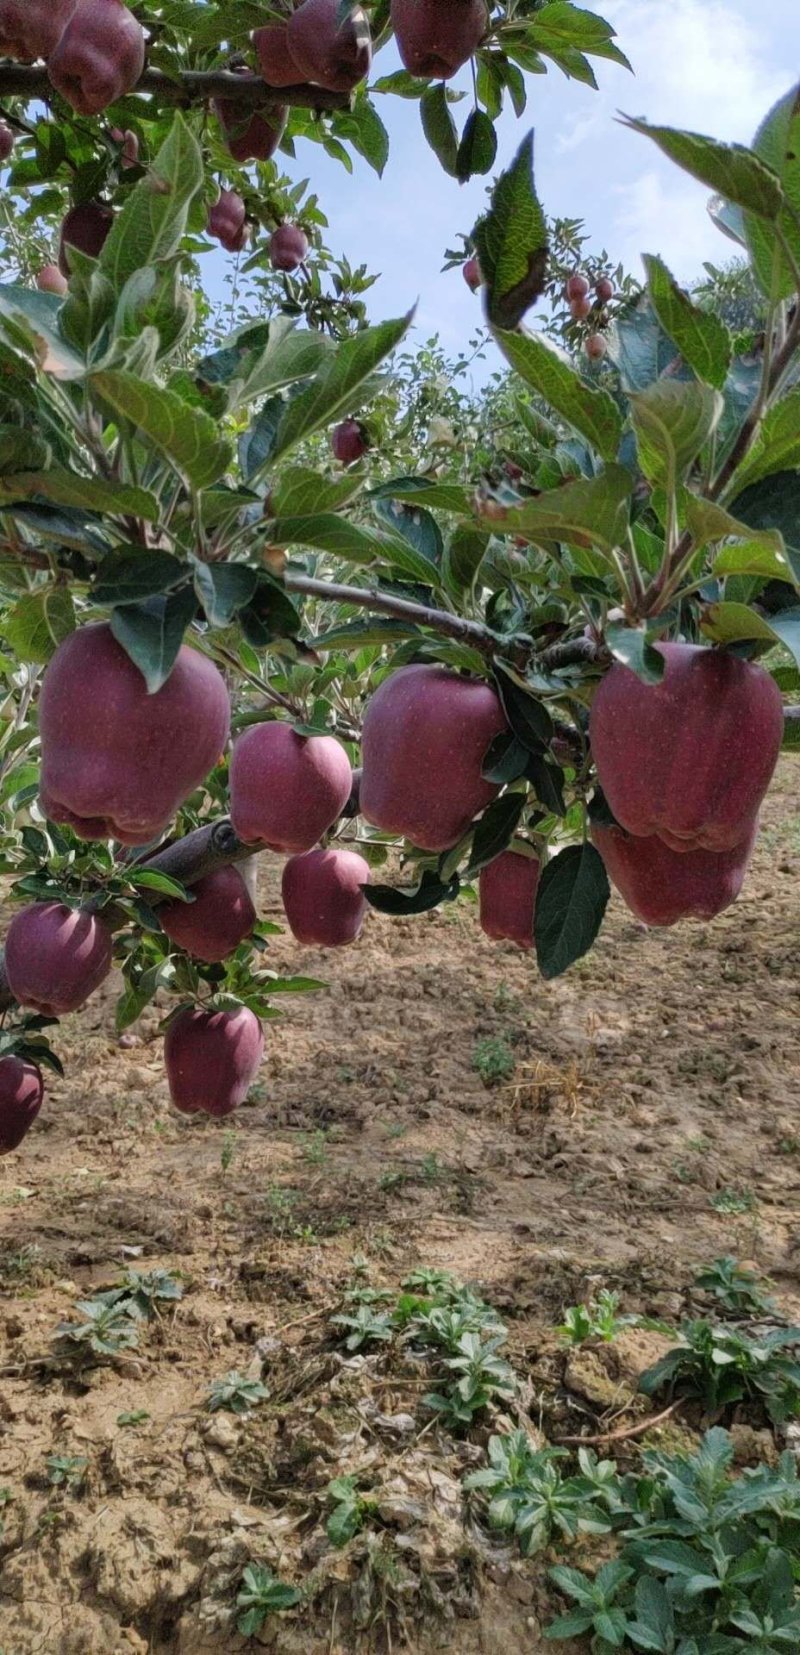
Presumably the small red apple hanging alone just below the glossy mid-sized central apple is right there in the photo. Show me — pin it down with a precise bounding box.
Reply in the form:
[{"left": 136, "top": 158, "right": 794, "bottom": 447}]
[{"left": 282, "top": 846, "right": 369, "bottom": 948}]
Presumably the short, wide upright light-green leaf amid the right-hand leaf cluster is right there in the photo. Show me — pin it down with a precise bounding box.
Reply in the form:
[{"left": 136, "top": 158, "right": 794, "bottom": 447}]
[{"left": 631, "top": 379, "right": 724, "bottom": 492}]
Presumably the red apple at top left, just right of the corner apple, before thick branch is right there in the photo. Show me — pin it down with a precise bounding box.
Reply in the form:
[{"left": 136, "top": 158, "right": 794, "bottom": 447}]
[{"left": 48, "top": 0, "right": 144, "bottom": 114}]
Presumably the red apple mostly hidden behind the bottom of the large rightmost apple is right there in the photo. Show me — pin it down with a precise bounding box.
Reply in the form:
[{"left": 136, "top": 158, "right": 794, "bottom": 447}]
[{"left": 591, "top": 821, "right": 759, "bottom": 925}]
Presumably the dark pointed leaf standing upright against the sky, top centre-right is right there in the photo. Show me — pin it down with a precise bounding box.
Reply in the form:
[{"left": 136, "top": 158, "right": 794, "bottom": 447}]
[{"left": 472, "top": 132, "right": 548, "bottom": 332}]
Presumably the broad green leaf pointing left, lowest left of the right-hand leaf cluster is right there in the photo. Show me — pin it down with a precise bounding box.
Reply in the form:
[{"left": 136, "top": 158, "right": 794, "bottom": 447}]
[{"left": 504, "top": 465, "right": 633, "bottom": 553}]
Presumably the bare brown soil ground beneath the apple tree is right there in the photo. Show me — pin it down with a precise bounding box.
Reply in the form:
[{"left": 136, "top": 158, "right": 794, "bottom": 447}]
[{"left": 0, "top": 761, "right": 800, "bottom": 1655}]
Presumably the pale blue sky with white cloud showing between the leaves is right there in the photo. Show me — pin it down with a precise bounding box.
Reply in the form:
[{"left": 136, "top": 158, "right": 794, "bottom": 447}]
[{"left": 250, "top": 0, "right": 800, "bottom": 366}]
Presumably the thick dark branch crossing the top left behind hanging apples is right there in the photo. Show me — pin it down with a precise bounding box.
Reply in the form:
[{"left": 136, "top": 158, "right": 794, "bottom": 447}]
[{"left": 0, "top": 63, "right": 351, "bottom": 109}]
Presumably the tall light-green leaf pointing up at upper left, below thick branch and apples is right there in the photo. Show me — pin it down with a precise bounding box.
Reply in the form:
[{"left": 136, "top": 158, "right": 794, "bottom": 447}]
[{"left": 99, "top": 113, "right": 205, "bottom": 293}]
